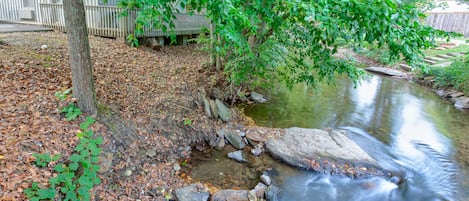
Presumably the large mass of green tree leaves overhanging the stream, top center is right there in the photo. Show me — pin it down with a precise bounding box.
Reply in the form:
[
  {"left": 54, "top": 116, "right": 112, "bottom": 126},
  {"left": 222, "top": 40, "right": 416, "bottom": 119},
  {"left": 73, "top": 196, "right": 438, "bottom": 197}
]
[{"left": 120, "top": 0, "right": 455, "bottom": 86}]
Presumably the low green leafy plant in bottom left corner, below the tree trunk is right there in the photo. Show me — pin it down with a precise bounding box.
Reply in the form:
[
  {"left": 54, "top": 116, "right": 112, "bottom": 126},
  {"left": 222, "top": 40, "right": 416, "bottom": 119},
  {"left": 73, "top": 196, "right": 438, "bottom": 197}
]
[{"left": 24, "top": 117, "right": 103, "bottom": 201}]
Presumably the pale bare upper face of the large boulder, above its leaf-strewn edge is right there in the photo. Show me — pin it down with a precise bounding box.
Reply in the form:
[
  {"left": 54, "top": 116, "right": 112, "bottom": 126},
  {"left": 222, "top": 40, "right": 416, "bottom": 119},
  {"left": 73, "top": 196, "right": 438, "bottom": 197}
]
[{"left": 266, "top": 128, "right": 377, "bottom": 171}]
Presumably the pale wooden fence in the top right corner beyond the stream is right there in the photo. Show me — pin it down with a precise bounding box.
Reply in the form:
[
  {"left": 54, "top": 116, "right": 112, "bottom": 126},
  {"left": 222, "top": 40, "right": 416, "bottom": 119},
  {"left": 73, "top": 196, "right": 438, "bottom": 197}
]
[{"left": 426, "top": 11, "right": 469, "bottom": 37}]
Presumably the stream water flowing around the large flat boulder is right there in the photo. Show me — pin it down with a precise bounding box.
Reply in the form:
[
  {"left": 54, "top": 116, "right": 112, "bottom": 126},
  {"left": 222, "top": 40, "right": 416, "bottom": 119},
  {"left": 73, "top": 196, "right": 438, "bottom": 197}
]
[{"left": 244, "top": 76, "right": 469, "bottom": 201}]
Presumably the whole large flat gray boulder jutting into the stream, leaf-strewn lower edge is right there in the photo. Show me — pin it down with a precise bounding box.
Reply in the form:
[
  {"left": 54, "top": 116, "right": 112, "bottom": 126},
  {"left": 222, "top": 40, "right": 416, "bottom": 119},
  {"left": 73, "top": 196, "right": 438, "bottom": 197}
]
[{"left": 266, "top": 128, "right": 384, "bottom": 177}]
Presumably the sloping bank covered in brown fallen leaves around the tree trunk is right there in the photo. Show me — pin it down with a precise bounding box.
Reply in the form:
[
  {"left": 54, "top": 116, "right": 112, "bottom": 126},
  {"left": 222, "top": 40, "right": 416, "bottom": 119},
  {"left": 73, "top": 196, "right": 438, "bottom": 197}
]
[{"left": 0, "top": 32, "right": 225, "bottom": 200}]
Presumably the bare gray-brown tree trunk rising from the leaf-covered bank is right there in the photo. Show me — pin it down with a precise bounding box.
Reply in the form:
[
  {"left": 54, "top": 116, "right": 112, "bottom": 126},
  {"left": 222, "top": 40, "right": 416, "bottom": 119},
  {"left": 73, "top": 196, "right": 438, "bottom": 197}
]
[{"left": 63, "top": 0, "right": 98, "bottom": 115}]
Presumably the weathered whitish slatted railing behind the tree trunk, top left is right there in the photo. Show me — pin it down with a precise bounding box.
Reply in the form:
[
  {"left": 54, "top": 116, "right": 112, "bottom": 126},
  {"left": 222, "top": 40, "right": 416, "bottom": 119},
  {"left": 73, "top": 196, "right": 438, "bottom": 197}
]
[{"left": 0, "top": 0, "right": 209, "bottom": 38}]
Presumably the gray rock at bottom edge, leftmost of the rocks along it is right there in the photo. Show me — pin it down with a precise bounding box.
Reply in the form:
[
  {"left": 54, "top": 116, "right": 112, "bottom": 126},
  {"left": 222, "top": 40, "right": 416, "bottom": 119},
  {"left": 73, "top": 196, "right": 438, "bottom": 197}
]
[{"left": 175, "top": 184, "right": 210, "bottom": 201}]
